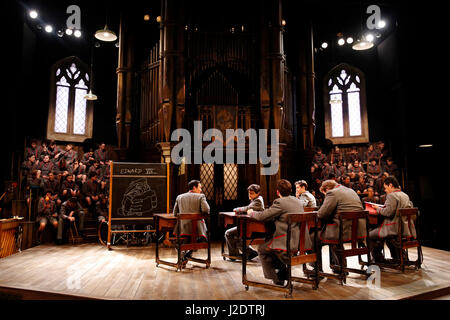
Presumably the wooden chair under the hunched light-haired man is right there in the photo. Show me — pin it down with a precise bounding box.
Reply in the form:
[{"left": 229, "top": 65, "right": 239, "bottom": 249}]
[{"left": 320, "top": 210, "right": 370, "bottom": 285}]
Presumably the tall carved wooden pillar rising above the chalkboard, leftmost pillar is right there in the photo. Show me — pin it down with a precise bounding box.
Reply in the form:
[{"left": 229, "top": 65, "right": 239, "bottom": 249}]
[{"left": 116, "top": 13, "right": 134, "bottom": 149}]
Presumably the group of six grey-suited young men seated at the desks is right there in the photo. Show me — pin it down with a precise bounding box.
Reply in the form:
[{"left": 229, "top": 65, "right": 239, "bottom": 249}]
[{"left": 173, "top": 177, "right": 416, "bottom": 285}]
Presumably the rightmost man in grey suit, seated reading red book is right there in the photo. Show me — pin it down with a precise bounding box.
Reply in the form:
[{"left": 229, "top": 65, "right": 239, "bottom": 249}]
[{"left": 369, "top": 176, "right": 417, "bottom": 262}]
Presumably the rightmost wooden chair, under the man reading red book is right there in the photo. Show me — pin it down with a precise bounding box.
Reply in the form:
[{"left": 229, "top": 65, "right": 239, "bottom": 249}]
[{"left": 374, "top": 208, "right": 423, "bottom": 272}]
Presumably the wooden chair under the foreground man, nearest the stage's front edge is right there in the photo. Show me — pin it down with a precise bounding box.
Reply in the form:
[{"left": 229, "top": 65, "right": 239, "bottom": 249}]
[{"left": 286, "top": 212, "right": 319, "bottom": 296}]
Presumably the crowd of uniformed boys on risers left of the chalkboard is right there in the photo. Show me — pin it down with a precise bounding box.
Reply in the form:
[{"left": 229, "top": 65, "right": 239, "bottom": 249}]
[{"left": 22, "top": 140, "right": 110, "bottom": 244}]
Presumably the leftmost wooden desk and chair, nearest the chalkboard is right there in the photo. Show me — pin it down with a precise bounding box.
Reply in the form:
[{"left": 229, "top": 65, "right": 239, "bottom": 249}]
[{"left": 155, "top": 213, "right": 211, "bottom": 271}]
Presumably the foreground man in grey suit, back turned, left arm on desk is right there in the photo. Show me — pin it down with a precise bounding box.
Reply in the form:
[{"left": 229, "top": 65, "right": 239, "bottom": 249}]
[{"left": 247, "top": 180, "right": 312, "bottom": 285}]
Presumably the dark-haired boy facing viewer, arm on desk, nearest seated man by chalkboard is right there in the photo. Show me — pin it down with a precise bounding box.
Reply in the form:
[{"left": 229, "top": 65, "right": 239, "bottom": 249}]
[{"left": 225, "top": 184, "right": 264, "bottom": 261}]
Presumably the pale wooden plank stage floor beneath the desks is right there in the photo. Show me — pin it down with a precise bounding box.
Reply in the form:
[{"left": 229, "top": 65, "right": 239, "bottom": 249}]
[{"left": 0, "top": 243, "right": 450, "bottom": 300}]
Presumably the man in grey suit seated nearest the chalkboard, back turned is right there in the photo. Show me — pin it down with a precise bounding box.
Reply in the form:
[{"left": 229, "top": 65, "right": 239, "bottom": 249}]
[{"left": 173, "top": 180, "right": 209, "bottom": 263}]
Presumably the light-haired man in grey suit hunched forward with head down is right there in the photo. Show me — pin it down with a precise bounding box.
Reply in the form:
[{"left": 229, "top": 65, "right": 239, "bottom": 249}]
[{"left": 317, "top": 180, "right": 366, "bottom": 272}]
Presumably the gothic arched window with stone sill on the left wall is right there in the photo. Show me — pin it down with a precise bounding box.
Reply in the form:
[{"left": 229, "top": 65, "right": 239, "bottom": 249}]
[{"left": 47, "top": 57, "right": 93, "bottom": 142}]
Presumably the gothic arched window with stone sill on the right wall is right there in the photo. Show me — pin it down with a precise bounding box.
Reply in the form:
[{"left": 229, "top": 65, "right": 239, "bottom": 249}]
[{"left": 324, "top": 64, "right": 369, "bottom": 144}]
